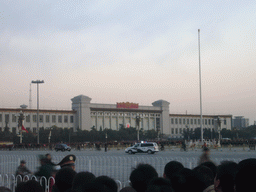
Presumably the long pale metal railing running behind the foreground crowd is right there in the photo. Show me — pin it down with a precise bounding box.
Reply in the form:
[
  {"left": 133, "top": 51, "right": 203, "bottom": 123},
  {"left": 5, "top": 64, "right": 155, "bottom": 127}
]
[{"left": 0, "top": 155, "right": 241, "bottom": 191}]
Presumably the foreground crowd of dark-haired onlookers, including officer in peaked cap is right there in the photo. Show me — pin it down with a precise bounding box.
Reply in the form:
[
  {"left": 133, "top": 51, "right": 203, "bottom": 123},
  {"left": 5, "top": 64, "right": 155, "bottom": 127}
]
[{"left": 0, "top": 147, "right": 256, "bottom": 192}]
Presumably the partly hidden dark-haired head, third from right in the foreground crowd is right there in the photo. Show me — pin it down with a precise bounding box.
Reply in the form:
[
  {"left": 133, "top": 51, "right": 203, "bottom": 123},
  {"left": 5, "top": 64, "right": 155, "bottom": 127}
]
[{"left": 193, "top": 165, "right": 214, "bottom": 188}]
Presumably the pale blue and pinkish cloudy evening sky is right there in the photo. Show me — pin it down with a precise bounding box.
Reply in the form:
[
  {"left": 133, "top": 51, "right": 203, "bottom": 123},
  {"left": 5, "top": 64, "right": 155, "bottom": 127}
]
[{"left": 0, "top": 0, "right": 256, "bottom": 124}]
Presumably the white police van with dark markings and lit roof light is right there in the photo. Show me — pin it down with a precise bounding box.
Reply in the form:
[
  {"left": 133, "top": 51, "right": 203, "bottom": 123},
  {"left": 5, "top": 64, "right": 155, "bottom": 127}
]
[{"left": 125, "top": 142, "right": 159, "bottom": 154}]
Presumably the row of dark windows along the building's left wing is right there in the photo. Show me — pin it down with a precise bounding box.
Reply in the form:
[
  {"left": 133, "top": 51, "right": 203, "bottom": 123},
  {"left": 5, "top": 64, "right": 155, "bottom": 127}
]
[{"left": 0, "top": 114, "right": 74, "bottom": 123}]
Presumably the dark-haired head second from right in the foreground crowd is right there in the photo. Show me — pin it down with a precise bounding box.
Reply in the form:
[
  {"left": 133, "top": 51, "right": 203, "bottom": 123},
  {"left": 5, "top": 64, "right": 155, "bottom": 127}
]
[{"left": 214, "top": 161, "right": 238, "bottom": 192}]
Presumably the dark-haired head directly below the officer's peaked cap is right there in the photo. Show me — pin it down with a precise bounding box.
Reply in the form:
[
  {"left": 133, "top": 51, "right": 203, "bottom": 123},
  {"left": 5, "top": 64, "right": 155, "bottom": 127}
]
[{"left": 55, "top": 167, "right": 76, "bottom": 192}]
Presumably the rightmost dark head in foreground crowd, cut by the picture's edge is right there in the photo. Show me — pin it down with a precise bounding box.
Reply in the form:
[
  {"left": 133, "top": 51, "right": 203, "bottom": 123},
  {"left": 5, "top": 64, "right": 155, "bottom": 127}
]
[{"left": 235, "top": 158, "right": 256, "bottom": 192}]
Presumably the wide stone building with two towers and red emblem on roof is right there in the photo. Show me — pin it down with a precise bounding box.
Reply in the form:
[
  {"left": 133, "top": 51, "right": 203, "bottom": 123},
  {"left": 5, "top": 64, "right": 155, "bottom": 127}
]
[{"left": 0, "top": 95, "right": 232, "bottom": 138}]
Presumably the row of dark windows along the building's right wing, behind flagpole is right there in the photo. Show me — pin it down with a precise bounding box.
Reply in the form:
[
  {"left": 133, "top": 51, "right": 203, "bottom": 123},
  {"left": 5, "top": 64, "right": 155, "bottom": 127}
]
[{"left": 171, "top": 118, "right": 227, "bottom": 125}]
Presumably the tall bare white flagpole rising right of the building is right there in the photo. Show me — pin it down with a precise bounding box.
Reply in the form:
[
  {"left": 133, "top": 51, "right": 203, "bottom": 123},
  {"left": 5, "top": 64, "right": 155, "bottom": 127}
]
[{"left": 198, "top": 29, "right": 204, "bottom": 143}]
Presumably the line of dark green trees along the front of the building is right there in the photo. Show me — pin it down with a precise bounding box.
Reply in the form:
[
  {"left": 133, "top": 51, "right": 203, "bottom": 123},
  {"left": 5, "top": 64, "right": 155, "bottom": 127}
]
[{"left": 0, "top": 125, "right": 256, "bottom": 144}]
